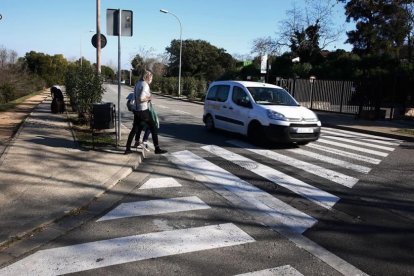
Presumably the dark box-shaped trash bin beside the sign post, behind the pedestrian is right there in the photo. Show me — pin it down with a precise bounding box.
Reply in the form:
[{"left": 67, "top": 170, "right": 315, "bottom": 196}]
[{"left": 91, "top": 103, "right": 115, "bottom": 129}]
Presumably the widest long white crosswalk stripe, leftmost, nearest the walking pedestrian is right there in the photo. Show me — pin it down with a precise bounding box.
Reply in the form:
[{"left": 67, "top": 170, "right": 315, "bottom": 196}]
[{"left": 166, "top": 150, "right": 317, "bottom": 233}]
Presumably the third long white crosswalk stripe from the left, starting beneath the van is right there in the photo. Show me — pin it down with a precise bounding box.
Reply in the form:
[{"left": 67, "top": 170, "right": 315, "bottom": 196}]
[{"left": 227, "top": 140, "right": 358, "bottom": 188}]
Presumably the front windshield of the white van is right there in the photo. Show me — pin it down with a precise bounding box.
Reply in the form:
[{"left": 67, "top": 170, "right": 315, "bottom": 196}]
[{"left": 247, "top": 87, "right": 299, "bottom": 106}]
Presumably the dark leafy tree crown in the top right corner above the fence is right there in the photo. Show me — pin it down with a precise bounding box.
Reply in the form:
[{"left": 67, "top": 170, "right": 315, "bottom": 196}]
[{"left": 340, "top": 0, "right": 414, "bottom": 58}]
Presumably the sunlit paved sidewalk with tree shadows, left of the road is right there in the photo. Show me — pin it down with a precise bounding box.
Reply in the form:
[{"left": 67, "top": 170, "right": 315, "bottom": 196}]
[{"left": 0, "top": 93, "right": 141, "bottom": 247}]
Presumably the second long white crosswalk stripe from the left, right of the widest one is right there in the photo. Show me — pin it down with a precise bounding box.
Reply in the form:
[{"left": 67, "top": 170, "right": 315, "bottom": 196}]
[{"left": 201, "top": 146, "right": 339, "bottom": 209}]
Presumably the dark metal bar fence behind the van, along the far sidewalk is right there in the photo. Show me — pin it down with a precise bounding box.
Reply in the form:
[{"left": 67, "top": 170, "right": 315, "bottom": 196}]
[{"left": 276, "top": 75, "right": 414, "bottom": 119}]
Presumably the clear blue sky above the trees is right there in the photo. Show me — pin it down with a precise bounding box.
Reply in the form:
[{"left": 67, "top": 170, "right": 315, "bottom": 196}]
[{"left": 0, "top": 0, "right": 351, "bottom": 69}]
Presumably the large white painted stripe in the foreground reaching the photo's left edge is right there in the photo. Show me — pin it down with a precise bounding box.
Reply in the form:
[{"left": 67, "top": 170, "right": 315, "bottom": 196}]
[{"left": 0, "top": 223, "right": 255, "bottom": 275}]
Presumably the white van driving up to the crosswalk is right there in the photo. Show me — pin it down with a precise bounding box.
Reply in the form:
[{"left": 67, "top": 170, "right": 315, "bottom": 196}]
[{"left": 203, "top": 81, "right": 321, "bottom": 144}]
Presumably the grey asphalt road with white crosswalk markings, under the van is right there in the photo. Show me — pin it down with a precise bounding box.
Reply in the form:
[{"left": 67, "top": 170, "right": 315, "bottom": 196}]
[{"left": 0, "top": 86, "right": 414, "bottom": 275}]
